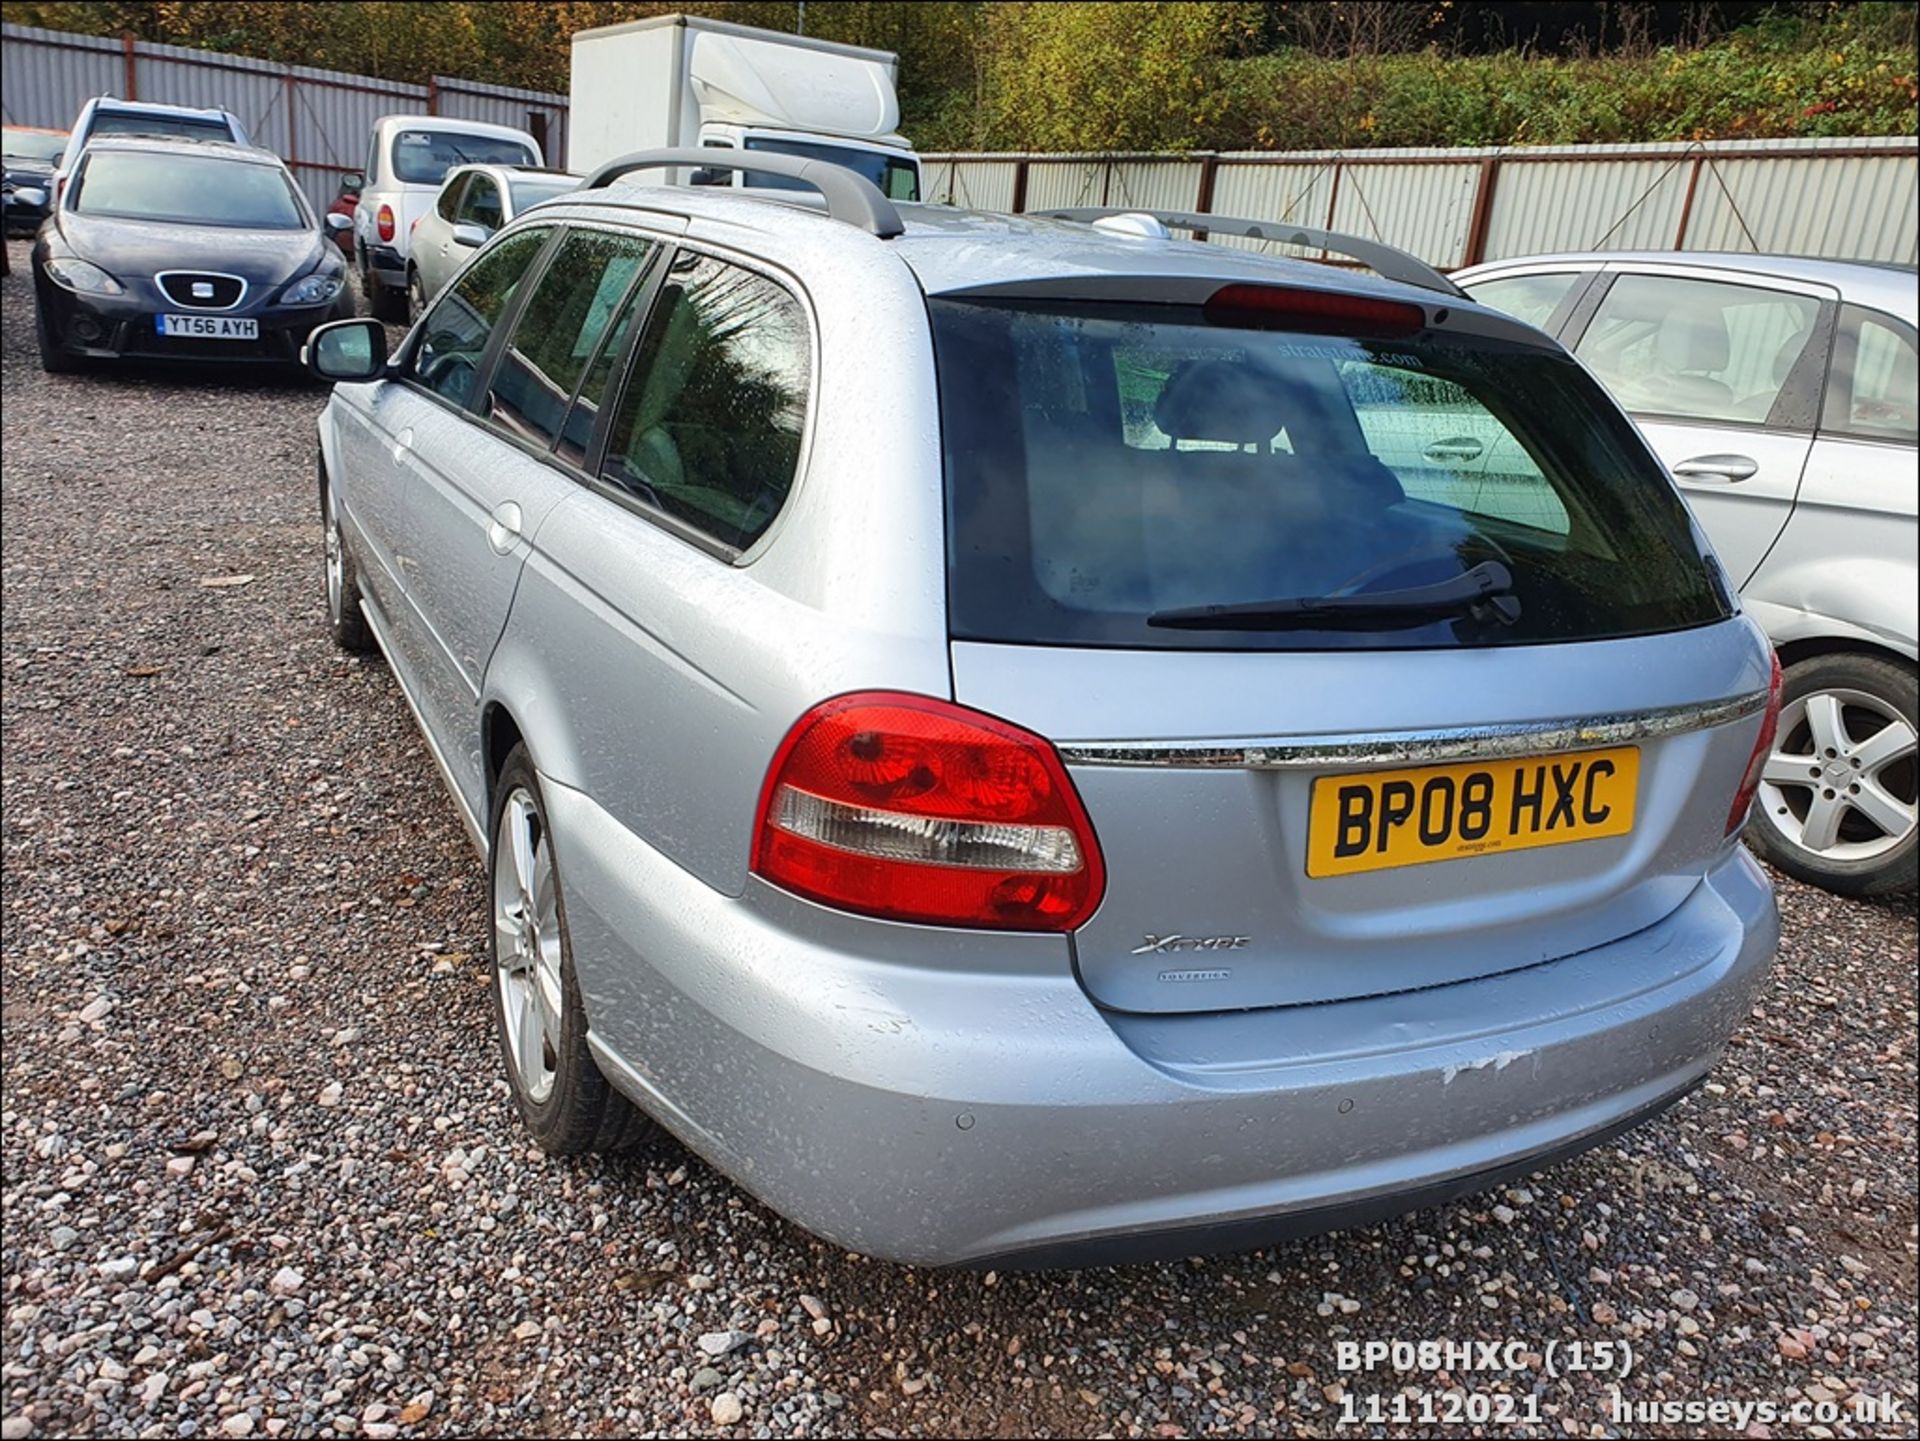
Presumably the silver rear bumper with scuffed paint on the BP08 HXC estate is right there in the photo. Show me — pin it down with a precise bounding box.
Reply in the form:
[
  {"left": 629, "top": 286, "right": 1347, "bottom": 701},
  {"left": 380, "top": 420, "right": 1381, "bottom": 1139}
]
[{"left": 547, "top": 781, "right": 1778, "bottom": 1264}]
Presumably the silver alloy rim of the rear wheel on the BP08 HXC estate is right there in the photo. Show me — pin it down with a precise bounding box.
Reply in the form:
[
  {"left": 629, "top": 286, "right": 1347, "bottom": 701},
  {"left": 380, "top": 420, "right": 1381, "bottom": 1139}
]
[{"left": 493, "top": 787, "right": 566, "bottom": 1105}]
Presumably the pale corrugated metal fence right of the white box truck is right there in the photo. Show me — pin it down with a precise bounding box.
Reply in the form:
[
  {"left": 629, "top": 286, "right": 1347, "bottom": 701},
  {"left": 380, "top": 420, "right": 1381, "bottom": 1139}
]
[{"left": 922, "top": 136, "right": 1920, "bottom": 269}]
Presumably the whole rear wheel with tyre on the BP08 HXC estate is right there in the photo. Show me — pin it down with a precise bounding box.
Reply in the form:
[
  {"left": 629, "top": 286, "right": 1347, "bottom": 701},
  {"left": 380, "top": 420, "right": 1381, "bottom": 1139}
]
[{"left": 488, "top": 746, "right": 655, "bottom": 1155}]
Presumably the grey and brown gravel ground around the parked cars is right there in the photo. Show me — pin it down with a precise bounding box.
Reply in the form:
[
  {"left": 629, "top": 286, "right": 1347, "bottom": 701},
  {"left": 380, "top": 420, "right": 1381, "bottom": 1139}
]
[{"left": 0, "top": 246, "right": 1916, "bottom": 1437}]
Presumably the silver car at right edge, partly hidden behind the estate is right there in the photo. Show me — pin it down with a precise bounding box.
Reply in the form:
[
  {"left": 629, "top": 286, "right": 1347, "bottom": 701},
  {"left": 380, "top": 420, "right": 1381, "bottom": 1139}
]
[{"left": 1453, "top": 251, "right": 1920, "bottom": 896}]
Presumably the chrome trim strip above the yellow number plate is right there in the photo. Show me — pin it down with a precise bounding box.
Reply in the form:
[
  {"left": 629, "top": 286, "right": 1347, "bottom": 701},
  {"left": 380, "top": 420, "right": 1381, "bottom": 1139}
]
[{"left": 1056, "top": 691, "right": 1766, "bottom": 771}]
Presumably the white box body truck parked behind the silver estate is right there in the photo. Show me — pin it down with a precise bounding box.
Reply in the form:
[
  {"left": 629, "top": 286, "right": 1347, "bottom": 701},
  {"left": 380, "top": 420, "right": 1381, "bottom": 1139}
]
[{"left": 566, "top": 15, "right": 920, "bottom": 200}]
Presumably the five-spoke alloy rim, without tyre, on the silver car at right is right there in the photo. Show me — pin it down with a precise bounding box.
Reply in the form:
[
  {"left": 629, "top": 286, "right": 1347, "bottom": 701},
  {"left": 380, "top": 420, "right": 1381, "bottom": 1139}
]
[{"left": 1759, "top": 689, "right": 1920, "bottom": 862}]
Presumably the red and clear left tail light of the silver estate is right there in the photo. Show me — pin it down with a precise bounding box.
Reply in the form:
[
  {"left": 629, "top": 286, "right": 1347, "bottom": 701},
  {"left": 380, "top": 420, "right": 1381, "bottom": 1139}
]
[{"left": 753, "top": 691, "right": 1106, "bottom": 931}]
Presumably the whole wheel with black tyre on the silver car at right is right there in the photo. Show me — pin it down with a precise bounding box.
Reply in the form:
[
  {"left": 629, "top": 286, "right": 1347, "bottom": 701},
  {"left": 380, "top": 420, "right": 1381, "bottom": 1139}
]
[{"left": 1747, "top": 652, "right": 1920, "bottom": 896}]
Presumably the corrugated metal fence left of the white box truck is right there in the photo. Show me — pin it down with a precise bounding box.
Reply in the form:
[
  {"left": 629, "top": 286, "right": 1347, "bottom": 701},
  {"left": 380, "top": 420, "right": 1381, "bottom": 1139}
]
[{"left": 0, "top": 25, "right": 566, "bottom": 209}]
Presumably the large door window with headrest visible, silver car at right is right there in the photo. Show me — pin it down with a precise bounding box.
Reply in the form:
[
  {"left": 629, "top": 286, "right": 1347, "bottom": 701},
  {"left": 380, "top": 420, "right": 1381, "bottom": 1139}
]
[{"left": 1574, "top": 274, "right": 1820, "bottom": 424}]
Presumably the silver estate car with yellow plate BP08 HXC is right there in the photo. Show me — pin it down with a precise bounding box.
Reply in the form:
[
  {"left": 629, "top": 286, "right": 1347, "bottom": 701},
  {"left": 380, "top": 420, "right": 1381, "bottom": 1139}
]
[{"left": 309, "top": 152, "right": 1778, "bottom": 1264}]
